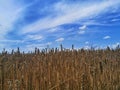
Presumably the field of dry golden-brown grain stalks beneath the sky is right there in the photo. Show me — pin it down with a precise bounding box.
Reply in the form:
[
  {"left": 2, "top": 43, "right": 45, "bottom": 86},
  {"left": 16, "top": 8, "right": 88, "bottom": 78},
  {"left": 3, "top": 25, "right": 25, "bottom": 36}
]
[{"left": 0, "top": 46, "right": 120, "bottom": 90}]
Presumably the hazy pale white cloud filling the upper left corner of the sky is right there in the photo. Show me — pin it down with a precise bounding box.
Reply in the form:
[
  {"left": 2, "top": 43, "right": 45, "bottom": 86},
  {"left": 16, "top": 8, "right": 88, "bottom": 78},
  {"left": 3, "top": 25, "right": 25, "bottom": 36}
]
[{"left": 0, "top": 0, "right": 31, "bottom": 39}]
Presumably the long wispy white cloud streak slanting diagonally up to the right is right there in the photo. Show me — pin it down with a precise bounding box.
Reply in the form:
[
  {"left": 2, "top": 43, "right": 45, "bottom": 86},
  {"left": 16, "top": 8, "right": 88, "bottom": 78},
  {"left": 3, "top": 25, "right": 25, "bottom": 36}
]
[{"left": 22, "top": 0, "right": 120, "bottom": 33}]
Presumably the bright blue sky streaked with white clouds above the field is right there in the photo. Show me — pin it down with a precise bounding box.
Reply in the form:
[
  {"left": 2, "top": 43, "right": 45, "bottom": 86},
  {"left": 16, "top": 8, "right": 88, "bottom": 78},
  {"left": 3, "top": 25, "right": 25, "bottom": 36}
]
[{"left": 0, "top": 0, "right": 120, "bottom": 51}]
